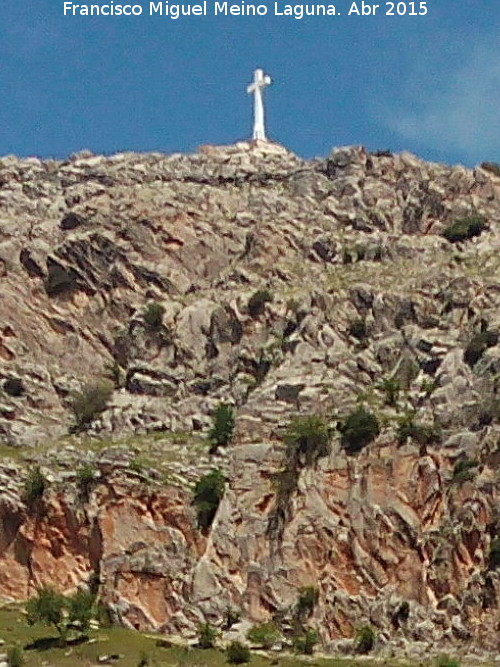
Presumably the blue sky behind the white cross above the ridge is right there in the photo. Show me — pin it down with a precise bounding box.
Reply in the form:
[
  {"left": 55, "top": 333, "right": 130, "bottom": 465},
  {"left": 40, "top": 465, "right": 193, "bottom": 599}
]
[{"left": 0, "top": 0, "right": 500, "bottom": 165}]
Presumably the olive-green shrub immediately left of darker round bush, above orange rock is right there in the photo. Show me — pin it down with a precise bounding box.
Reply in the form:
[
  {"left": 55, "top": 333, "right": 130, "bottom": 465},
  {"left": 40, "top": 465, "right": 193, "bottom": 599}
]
[{"left": 284, "top": 415, "right": 330, "bottom": 466}]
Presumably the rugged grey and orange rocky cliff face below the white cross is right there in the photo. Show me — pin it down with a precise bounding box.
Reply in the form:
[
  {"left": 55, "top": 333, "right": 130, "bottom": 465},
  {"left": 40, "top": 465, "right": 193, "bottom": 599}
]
[{"left": 0, "top": 144, "right": 500, "bottom": 649}]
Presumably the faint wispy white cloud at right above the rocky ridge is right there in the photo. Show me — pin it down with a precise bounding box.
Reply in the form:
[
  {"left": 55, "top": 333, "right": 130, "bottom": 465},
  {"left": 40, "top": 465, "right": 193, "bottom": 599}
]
[{"left": 385, "top": 42, "right": 500, "bottom": 162}]
